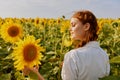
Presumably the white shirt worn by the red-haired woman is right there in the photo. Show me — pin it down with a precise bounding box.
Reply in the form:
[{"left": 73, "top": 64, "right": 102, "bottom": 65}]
[{"left": 61, "top": 41, "right": 110, "bottom": 80}]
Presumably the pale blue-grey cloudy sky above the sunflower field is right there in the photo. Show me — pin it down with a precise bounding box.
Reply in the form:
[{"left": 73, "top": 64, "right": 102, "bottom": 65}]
[{"left": 0, "top": 0, "right": 120, "bottom": 18}]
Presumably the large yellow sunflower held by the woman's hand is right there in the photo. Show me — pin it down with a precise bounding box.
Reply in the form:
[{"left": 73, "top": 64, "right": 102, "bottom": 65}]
[{"left": 12, "top": 36, "right": 44, "bottom": 70}]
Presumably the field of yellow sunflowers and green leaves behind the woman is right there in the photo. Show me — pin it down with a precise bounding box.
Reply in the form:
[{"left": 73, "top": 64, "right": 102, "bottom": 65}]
[{"left": 0, "top": 17, "right": 120, "bottom": 80}]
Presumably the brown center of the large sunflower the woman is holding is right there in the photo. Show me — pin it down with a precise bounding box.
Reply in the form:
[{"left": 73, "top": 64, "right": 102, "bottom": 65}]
[{"left": 23, "top": 44, "right": 37, "bottom": 62}]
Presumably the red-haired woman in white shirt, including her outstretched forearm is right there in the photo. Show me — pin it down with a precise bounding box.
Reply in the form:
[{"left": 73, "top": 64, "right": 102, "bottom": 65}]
[{"left": 23, "top": 10, "right": 110, "bottom": 80}]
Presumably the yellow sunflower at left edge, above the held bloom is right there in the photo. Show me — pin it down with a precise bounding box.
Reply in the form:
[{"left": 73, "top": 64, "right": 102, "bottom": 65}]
[{"left": 0, "top": 23, "right": 23, "bottom": 43}]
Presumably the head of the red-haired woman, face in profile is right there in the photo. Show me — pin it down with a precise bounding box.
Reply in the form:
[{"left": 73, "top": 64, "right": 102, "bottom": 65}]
[{"left": 70, "top": 10, "right": 98, "bottom": 46}]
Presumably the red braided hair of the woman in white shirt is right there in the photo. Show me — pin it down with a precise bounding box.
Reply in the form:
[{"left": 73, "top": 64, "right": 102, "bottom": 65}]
[{"left": 72, "top": 10, "right": 99, "bottom": 47}]
